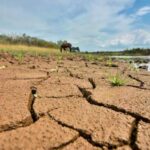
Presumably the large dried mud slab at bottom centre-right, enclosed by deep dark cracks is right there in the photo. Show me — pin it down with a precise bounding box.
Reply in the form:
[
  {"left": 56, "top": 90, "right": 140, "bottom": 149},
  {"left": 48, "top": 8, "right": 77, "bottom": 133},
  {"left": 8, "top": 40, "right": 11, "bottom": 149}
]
[{"left": 49, "top": 98, "right": 133, "bottom": 146}]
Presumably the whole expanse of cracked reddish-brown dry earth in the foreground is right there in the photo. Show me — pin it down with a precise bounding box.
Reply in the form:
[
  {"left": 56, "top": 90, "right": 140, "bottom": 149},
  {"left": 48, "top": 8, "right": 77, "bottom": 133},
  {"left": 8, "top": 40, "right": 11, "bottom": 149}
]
[{"left": 0, "top": 54, "right": 150, "bottom": 150}]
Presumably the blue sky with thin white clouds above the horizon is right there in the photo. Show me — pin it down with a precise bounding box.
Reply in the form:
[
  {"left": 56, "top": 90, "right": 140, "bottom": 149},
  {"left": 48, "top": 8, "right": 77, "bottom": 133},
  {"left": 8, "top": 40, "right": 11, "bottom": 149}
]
[{"left": 0, "top": 0, "right": 150, "bottom": 51}]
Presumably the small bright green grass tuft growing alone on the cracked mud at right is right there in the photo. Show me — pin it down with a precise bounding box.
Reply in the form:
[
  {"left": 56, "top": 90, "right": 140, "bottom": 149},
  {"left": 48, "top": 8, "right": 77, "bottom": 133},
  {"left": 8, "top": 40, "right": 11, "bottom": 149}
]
[{"left": 109, "top": 74, "right": 126, "bottom": 86}]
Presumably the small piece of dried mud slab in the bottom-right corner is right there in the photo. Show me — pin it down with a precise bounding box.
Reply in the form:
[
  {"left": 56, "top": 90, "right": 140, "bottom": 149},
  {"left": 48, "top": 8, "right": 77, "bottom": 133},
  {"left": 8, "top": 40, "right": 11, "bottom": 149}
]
[{"left": 136, "top": 121, "right": 150, "bottom": 150}]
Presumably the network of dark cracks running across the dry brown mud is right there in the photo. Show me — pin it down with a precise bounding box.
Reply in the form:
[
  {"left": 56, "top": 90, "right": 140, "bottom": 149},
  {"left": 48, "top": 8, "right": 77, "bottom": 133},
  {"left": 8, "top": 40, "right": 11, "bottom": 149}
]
[{"left": 0, "top": 55, "right": 150, "bottom": 150}]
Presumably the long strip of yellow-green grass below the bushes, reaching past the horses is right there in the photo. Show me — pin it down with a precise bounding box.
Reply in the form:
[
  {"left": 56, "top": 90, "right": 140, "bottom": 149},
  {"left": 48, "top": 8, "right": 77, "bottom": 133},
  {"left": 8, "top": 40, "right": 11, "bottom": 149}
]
[{"left": 0, "top": 44, "right": 105, "bottom": 62}]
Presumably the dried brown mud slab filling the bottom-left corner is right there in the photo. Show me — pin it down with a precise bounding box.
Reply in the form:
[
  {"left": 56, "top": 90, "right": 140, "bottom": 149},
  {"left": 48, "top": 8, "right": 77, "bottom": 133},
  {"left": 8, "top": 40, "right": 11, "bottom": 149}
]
[{"left": 0, "top": 117, "right": 78, "bottom": 150}]
